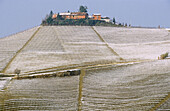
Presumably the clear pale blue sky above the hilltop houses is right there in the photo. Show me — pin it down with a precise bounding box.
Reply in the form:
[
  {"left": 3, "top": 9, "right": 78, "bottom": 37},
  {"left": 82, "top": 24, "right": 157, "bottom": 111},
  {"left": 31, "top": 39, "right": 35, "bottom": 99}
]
[{"left": 0, "top": 0, "right": 170, "bottom": 38}]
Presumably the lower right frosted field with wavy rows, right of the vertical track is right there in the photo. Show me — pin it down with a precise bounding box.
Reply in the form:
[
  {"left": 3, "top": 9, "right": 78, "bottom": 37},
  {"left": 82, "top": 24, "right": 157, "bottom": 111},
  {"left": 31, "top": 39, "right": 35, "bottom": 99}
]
[{"left": 82, "top": 60, "right": 170, "bottom": 111}]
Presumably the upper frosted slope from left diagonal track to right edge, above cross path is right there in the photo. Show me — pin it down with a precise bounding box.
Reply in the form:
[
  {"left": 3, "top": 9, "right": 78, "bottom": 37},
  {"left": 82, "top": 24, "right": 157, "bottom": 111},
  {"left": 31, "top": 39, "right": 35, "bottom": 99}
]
[{"left": 2, "top": 26, "right": 170, "bottom": 73}]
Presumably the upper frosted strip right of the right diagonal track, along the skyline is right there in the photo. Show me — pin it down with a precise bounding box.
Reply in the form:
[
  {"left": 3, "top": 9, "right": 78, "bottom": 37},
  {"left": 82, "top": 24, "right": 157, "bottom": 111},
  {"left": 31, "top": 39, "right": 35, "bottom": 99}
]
[{"left": 95, "top": 27, "right": 170, "bottom": 44}]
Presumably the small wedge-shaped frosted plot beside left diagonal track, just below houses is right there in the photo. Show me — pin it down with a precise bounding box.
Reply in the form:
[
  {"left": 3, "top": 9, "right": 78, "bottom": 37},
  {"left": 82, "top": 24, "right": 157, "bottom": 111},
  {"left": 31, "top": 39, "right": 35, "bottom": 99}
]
[{"left": 23, "top": 27, "right": 64, "bottom": 52}]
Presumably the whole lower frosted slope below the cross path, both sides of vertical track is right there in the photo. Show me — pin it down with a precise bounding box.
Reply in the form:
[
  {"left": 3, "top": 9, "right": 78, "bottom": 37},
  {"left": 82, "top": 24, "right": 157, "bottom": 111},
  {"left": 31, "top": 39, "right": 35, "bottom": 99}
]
[{"left": 0, "top": 59, "right": 170, "bottom": 111}]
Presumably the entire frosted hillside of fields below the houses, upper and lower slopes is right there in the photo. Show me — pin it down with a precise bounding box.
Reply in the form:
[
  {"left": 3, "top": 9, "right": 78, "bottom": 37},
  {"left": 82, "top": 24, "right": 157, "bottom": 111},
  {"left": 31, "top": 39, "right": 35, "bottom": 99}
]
[{"left": 0, "top": 26, "right": 170, "bottom": 111}]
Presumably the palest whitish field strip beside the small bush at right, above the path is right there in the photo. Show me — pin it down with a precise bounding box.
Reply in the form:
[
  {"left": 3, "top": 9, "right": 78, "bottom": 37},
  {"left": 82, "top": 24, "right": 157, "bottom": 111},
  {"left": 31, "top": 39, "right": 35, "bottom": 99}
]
[{"left": 110, "top": 42, "right": 170, "bottom": 60}]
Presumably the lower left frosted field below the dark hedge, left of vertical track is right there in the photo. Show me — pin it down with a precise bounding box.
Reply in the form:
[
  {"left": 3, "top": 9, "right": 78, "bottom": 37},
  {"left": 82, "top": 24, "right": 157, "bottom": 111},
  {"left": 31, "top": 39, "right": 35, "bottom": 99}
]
[{"left": 0, "top": 76, "right": 79, "bottom": 111}]
